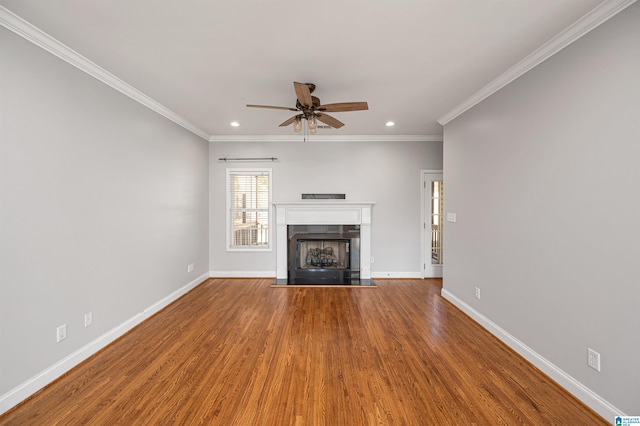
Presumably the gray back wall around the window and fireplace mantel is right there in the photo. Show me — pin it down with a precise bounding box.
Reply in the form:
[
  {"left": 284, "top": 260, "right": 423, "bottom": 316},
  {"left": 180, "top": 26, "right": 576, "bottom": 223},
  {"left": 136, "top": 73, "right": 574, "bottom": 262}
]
[{"left": 209, "top": 140, "right": 442, "bottom": 277}]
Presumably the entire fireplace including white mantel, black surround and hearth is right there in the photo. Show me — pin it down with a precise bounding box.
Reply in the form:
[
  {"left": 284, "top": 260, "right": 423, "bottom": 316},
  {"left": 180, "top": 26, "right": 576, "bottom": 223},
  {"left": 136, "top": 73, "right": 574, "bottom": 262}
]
[{"left": 274, "top": 200, "right": 375, "bottom": 286}]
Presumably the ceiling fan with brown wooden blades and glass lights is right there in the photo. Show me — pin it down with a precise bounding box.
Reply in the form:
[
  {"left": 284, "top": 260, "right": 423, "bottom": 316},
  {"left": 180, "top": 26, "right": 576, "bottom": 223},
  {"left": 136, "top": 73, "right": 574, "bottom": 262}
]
[{"left": 247, "top": 82, "right": 369, "bottom": 133}]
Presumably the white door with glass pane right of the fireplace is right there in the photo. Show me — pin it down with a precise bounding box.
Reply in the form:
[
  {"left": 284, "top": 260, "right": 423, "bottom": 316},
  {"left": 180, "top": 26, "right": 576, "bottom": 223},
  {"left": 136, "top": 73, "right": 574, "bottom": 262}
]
[{"left": 422, "top": 172, "right": 444, "bottom": 278}]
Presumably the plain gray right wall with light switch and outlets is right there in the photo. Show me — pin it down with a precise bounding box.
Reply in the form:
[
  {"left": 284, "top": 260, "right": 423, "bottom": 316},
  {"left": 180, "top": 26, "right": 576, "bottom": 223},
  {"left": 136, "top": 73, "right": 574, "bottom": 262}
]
[{"left": 444, "top": 3, "right": 640, "bottom": 415}]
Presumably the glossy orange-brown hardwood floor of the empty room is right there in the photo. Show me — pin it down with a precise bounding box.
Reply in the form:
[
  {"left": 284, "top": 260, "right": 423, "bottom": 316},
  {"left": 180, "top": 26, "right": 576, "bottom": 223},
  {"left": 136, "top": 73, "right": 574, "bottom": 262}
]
[{"left": 0, "top": 279, "right": 609, "bottom": 426}]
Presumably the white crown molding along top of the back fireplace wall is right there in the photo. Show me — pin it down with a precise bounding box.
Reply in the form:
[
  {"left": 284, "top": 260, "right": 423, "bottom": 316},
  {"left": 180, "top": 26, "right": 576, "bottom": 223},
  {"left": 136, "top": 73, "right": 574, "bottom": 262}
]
[{"left": 209, "top": 134, "right": 443, "bottom": 142}]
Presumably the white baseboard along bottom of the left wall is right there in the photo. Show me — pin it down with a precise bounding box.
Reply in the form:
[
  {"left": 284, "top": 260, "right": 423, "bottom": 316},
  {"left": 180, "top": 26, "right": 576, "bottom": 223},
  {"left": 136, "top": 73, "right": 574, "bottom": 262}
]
[{"left": 0, "top": 273, "right": 209, "bottom": 414}]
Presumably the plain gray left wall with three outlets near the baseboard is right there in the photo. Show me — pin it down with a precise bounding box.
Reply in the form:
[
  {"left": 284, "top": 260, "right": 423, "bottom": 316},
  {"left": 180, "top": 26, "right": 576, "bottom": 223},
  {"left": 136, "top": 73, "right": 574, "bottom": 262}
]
[{"left": 0, "top": 28, "right": 209, "bottom": 395}]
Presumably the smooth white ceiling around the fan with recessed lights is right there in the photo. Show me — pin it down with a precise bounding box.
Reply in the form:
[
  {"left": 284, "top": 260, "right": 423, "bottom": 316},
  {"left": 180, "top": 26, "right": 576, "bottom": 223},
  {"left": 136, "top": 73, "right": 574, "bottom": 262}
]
[{"left": 0, "top": 0, "right": 603, "bottom": 139}]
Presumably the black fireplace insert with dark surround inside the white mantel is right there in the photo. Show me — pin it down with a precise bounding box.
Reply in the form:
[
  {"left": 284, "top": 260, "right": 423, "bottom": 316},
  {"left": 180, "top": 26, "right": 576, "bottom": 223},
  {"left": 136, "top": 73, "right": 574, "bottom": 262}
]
[{"left": 287, "top": 225, "right": 360, "bottom": 284}]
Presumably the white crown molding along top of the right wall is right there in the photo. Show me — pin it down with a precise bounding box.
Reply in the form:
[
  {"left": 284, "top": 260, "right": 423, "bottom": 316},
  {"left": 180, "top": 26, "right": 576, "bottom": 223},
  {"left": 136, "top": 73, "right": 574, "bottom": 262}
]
[{"left": 438, "top": 0, "right": 636, "bottom": 126}]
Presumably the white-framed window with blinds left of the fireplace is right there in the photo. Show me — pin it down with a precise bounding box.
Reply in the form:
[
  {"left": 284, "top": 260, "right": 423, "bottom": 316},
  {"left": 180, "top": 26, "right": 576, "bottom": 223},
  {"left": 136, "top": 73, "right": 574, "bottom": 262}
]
[{"left": 227, "top": 169, "right": 271, "bottom": 250}]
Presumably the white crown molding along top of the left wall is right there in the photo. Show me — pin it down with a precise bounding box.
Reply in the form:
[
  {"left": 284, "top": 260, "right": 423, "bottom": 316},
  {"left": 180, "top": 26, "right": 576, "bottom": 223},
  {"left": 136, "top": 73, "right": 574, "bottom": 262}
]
[{"left": 0, "top": 6, "right": 209, "bottom": 140}]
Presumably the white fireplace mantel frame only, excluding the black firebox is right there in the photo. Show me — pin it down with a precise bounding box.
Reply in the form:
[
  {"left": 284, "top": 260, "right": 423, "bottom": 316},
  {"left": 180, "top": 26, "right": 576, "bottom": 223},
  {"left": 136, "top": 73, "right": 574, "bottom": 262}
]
[{"left": 273, "top": 200, "right": 374, "bottom": 279}]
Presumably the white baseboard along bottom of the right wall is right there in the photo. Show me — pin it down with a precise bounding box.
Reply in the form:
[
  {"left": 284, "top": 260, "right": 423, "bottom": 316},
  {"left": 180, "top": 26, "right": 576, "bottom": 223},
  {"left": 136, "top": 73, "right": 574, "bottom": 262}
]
[{"left": 442, "top": 289, "right": 625, "bottom": 420}]
